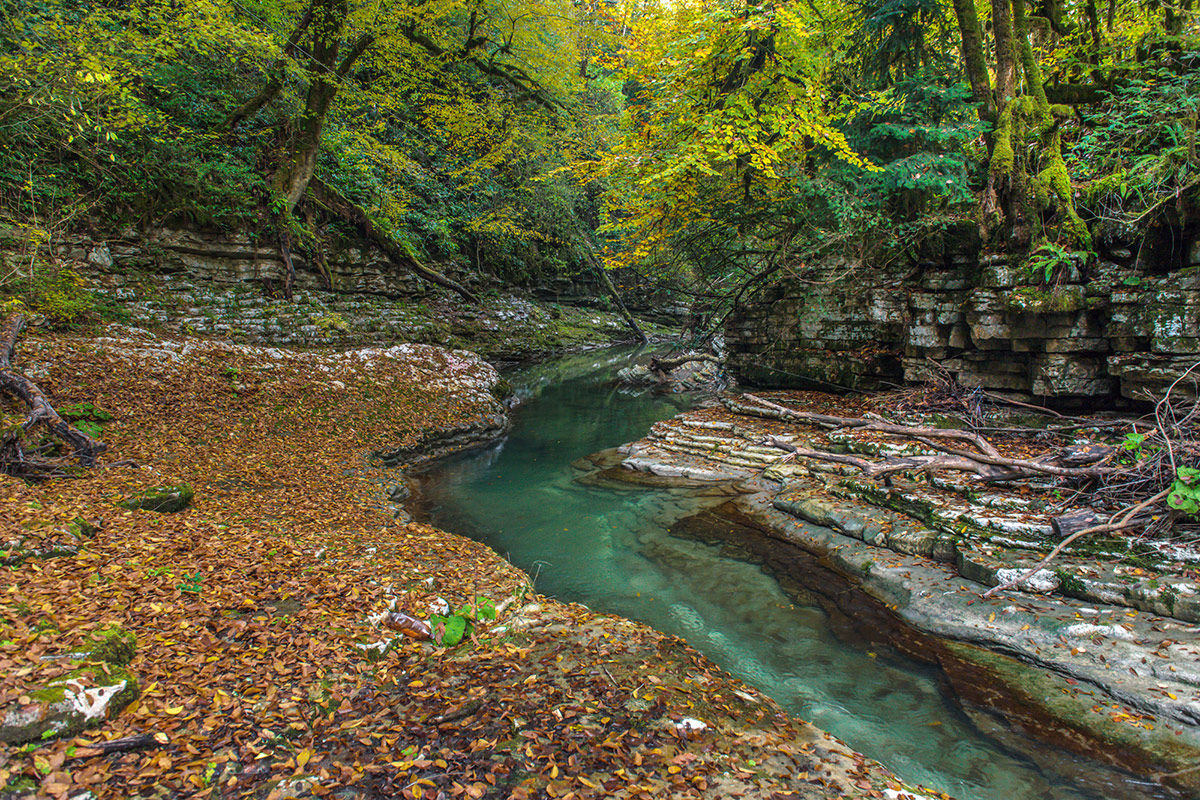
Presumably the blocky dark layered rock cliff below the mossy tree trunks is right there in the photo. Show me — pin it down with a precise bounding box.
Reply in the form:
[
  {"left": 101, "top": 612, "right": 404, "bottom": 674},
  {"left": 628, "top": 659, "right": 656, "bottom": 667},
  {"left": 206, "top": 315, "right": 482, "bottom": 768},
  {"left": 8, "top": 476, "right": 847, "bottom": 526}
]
[{"left": 726, "top": 226, "right": 1200, "bottom": 404}]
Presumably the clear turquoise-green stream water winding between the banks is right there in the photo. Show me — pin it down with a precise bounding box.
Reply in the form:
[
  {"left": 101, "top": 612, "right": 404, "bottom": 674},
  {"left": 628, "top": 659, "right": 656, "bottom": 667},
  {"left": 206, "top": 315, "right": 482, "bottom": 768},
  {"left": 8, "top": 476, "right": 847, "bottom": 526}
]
[{"left": 425, "top": 351, "right": 1148, "bottom": 800}]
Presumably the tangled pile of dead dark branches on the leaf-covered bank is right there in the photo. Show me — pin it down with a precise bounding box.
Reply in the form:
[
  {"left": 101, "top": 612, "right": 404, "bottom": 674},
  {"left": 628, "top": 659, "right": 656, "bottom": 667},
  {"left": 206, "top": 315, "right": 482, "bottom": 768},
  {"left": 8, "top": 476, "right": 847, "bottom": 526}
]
[{"left": 0, "top": 313, "right": 107, "bottom": 480}]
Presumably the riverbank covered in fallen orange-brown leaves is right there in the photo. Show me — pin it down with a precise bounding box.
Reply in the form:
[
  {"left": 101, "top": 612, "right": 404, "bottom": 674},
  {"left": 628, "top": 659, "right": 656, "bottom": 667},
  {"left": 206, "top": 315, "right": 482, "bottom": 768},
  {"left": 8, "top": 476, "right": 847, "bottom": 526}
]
[{"left": 0, "top": 329, "right": 926, "bottom": 799}]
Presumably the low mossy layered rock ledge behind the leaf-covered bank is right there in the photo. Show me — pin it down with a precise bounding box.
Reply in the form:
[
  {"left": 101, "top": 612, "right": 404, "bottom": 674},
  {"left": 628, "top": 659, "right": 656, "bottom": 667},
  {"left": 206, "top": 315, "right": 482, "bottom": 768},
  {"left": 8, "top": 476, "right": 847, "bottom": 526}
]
[{"left": 23, "top": 229, "right": 672, "bottom": 360}]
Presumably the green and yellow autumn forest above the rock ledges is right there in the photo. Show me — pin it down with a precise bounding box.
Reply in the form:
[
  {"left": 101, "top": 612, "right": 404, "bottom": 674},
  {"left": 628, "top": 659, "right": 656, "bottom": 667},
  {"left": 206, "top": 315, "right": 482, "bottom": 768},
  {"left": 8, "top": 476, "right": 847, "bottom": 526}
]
[{"left": 0, "top": 0, "right": 1200, "bottom": 307}]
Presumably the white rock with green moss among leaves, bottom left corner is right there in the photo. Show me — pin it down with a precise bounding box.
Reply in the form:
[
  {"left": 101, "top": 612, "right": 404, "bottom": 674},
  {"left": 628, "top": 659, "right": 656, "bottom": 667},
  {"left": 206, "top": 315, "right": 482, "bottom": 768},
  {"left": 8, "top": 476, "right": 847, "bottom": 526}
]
[{"left": 0, "top": 663, "right": 139, "bottom": 745}]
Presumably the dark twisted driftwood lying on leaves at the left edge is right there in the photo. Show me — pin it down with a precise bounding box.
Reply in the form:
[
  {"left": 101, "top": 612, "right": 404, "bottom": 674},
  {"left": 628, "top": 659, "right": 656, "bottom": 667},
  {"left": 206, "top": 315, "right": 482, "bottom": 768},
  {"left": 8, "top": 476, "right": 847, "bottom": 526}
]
[{"left": 0, "top": 313, "right": 108, "bottom": 476}]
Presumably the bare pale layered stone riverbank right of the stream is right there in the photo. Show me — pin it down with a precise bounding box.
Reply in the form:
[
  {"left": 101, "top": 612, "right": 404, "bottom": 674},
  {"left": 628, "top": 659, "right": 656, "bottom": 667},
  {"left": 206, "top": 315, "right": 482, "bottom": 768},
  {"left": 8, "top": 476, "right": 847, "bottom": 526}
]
[{"left": 595, "top": 392, "right": 1200, "bottom": 796}]
